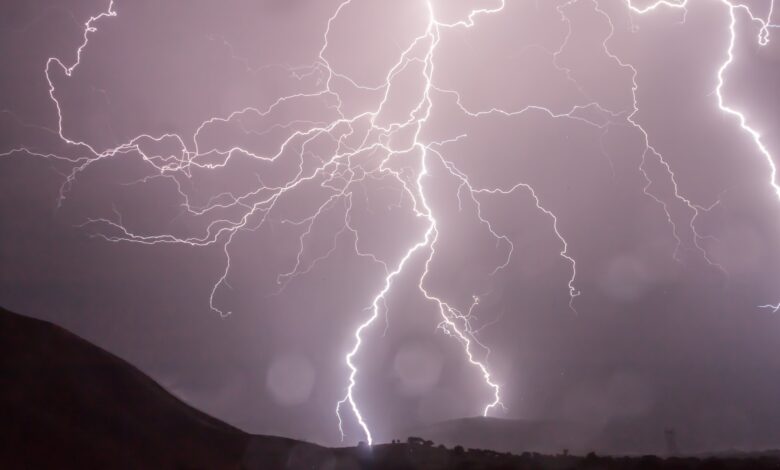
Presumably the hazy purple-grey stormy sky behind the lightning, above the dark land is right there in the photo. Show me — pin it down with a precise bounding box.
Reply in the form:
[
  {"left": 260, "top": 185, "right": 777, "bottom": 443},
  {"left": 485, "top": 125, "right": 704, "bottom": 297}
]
[{"left": 0, "top": 0, "right": 780, "bottom": 451}]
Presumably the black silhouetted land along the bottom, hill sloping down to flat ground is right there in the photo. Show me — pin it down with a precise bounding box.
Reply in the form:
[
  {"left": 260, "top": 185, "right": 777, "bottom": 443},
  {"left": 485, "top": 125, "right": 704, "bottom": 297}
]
[{"left": 0, "top": 309, "right": 780, "bottom": 470}]
